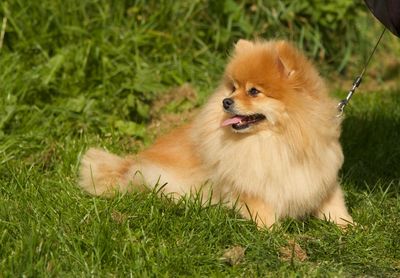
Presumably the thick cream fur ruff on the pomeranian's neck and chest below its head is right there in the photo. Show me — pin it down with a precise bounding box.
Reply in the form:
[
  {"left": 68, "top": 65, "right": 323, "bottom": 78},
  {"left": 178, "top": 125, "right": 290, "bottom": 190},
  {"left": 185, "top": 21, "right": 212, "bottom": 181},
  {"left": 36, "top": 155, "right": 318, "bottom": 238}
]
[{"left": 195, "top": 109, "right": 343, "bottom": 217}]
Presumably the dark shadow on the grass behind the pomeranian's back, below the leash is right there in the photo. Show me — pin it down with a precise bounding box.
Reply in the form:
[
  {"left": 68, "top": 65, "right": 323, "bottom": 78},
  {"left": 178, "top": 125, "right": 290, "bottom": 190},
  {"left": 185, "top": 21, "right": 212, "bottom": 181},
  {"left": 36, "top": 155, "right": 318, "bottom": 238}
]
[{"left": 341, "top": 92, "right": 400, "bottom": 193}]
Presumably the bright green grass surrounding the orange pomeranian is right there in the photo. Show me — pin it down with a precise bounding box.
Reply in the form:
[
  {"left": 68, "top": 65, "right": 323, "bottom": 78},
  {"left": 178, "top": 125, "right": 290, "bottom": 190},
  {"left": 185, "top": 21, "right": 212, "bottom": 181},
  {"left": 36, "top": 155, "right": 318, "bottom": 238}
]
[{"left": 0, "top": 0, "right": 400, "bottom": 277}]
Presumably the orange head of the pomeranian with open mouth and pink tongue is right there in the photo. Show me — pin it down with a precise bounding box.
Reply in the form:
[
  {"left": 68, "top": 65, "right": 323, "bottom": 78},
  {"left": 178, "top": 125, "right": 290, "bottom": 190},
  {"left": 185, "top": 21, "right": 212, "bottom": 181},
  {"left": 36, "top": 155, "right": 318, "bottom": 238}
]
[{"left": 221, "top": 40, "right": 319, "bottom": 133}]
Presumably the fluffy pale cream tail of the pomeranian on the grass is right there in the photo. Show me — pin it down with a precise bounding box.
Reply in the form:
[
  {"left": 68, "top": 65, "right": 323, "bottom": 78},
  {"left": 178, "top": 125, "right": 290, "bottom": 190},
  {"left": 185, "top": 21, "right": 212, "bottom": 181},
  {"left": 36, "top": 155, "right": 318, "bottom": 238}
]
[{"left": 79, "top": 148, "right": 133, "bottom": 197}]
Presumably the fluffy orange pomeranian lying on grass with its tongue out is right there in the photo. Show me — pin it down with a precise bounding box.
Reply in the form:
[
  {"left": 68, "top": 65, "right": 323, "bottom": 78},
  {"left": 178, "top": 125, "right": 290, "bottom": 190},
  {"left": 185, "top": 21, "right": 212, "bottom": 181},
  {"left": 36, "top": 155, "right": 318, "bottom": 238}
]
[{"left": 80, "top": 40, "right": 352, "bottom": 227}]
